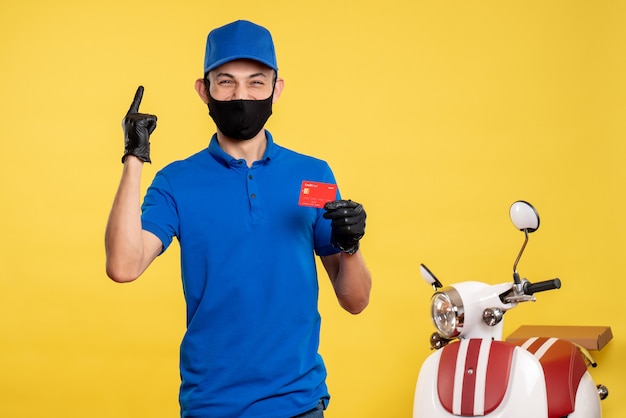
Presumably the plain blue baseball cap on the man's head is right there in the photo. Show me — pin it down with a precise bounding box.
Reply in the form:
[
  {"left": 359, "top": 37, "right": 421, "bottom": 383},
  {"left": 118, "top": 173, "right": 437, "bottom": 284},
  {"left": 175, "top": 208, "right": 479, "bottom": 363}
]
[{"left": 204, "top": 20, "right": 278, "bottom": 75}]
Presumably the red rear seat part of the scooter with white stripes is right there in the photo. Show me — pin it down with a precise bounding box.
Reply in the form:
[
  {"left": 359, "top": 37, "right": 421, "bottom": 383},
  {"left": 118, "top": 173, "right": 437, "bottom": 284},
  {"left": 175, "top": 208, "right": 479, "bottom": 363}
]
[{"left": 517, "top": 337, "right": 587, "bottom": 418}]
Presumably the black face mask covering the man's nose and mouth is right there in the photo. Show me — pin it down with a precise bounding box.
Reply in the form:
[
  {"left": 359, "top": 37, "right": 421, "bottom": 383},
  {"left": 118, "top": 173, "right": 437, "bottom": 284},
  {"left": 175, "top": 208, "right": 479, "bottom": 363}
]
[{"left": 207, "top": 89, "right": 274, "bottom": 139}]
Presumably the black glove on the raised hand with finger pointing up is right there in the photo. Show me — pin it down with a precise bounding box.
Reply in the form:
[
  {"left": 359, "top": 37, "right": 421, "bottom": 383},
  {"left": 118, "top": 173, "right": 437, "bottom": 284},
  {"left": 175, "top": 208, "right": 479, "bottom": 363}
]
[{"left": 122, "top": 86, "right": 157, "bottom": 163}]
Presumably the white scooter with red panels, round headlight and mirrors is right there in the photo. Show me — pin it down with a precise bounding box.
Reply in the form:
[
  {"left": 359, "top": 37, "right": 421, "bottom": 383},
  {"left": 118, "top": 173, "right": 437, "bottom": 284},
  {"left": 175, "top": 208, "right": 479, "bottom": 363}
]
[{"left": 413, "top": 201, "right": 608, "bottom": 418}]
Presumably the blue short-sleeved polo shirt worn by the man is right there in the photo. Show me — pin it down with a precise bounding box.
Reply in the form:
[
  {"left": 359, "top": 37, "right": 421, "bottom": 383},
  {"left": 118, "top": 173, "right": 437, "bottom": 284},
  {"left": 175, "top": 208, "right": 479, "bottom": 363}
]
[{"left": 142, "top": 131, "right": 339, "bottom": 418}]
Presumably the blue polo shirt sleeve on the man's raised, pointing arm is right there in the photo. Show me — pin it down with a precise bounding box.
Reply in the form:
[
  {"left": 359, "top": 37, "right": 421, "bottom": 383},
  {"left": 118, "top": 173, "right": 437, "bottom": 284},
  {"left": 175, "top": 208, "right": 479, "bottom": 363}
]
[{"left": 141, "top": 173, "right": 179, "bottom": 252}]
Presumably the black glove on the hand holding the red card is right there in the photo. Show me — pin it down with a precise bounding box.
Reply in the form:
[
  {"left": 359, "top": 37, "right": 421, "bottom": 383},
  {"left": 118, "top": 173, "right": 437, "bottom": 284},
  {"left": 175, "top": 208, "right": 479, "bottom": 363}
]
[{"left": 324, "top": 200, "right": 365, "bottom": 254}]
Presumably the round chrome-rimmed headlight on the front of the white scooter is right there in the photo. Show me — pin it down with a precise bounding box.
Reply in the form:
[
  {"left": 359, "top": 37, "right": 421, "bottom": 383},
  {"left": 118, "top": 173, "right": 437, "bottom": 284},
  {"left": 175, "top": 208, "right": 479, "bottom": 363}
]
[{"left": 430, "top": 287, "right": 465, "bottom": 338}]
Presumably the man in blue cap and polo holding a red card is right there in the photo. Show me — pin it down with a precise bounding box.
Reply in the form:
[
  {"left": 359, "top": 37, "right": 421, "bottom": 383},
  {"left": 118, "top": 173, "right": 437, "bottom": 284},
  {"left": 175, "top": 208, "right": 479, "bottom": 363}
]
[{"left": 105, "top": 21, "right": 371, "bottom": 418}]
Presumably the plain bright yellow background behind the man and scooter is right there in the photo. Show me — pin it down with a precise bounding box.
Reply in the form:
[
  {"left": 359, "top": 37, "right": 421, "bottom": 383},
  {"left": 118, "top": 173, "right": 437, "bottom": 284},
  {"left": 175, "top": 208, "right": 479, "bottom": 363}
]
[{"left": 0, "top": 0, "right": 626, "bottom": 418}]
